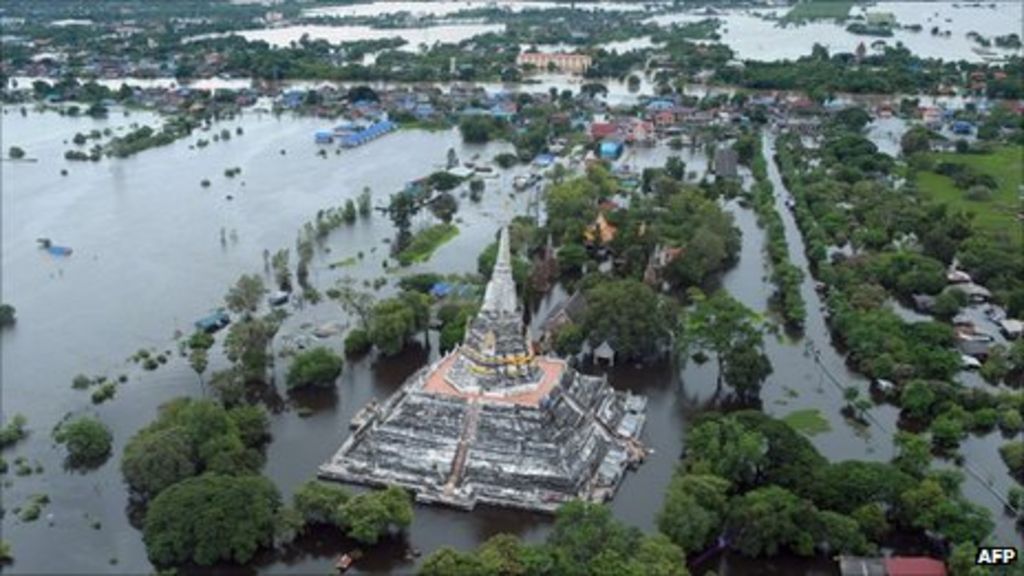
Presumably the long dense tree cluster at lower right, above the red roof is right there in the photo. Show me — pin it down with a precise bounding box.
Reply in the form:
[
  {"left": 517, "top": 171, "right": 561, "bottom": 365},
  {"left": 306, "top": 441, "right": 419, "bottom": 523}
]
[{"left": 658, "top": 411, "right": 993, "bottom": 557}]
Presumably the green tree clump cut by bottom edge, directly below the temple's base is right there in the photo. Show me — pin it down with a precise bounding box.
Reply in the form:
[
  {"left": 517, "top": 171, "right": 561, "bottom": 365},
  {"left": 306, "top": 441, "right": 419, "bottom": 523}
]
[{"left": 420, "top": 501, "right": 689, "bottom": 576}]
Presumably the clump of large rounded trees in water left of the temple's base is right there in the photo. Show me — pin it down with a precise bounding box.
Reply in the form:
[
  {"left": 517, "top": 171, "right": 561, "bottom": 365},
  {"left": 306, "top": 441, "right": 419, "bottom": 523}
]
[{"left": 121, "top": 398, "right": 280, "bottom": 565}]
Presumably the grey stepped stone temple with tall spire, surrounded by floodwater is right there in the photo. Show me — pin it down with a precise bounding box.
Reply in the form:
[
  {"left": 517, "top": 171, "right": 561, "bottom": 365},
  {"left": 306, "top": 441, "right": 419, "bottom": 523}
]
[{"left": 319, "top": 229, "right": 646, "bottom": 511}]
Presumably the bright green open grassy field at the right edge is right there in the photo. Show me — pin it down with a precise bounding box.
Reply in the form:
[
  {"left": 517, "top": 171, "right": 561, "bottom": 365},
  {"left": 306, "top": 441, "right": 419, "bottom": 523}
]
[{"left": 918, "top": 146, "right": 1024, "bottom": 238}]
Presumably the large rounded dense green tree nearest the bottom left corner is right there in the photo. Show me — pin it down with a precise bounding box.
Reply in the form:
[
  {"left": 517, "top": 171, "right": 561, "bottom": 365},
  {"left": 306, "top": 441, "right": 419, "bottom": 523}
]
[{"left": 142, "top": 475, "right": 281, "bottom": 566}]
